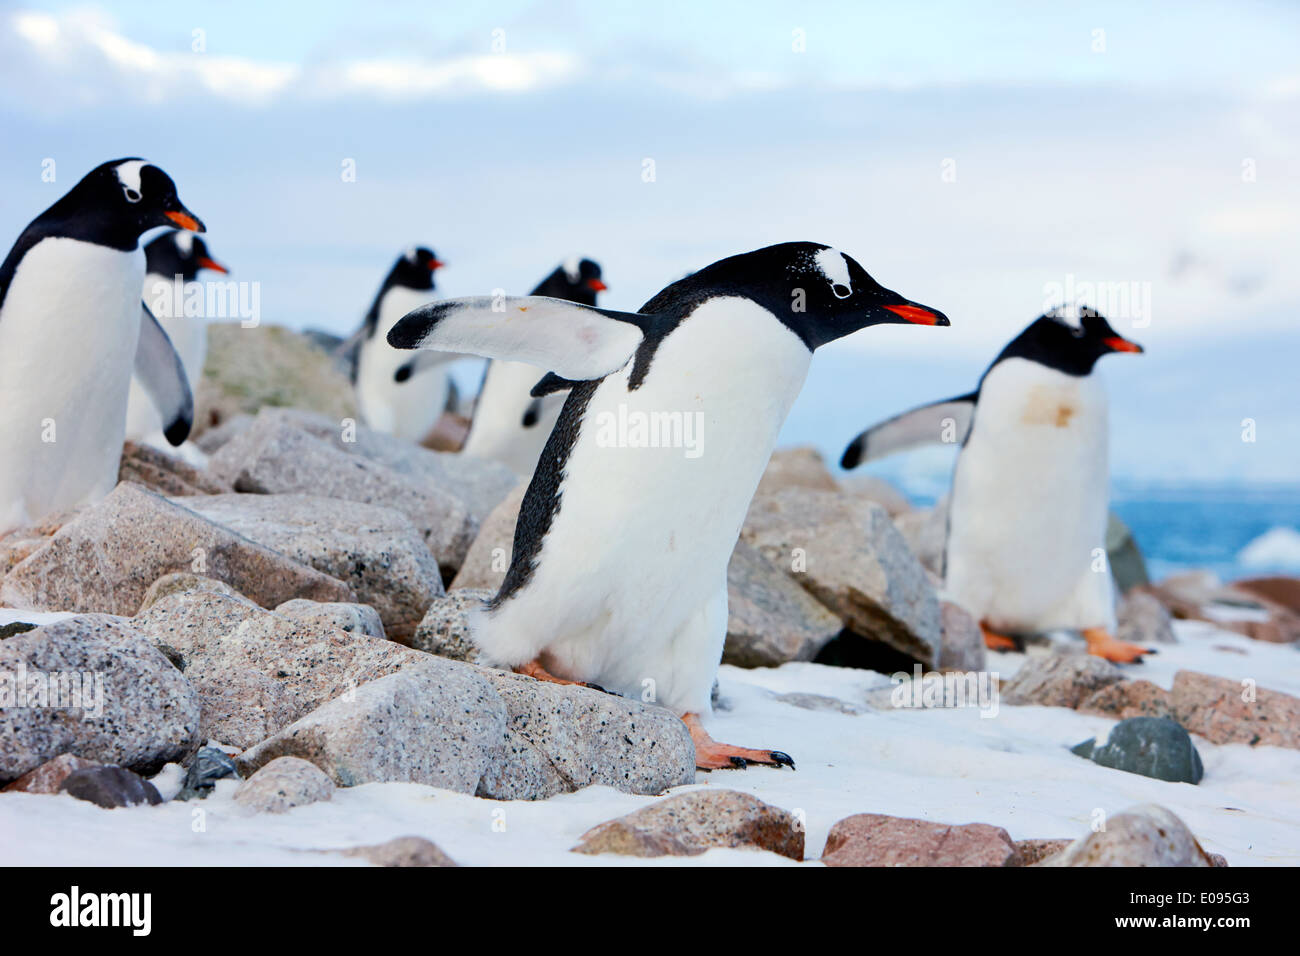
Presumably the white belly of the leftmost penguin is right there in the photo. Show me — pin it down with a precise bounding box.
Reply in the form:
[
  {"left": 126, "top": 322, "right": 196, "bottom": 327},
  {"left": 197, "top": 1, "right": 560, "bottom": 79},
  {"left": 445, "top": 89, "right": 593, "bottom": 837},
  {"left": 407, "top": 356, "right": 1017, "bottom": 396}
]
[{"left": 0, "top": 238, "right": 144, "bottom": 528}]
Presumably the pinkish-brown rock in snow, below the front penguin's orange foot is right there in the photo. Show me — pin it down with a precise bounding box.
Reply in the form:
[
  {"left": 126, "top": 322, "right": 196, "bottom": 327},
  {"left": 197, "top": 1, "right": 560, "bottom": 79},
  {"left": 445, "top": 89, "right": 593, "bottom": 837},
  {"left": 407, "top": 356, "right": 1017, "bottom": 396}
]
[{"left": 573, "top": 790, "right": 803, "bottom": 860}]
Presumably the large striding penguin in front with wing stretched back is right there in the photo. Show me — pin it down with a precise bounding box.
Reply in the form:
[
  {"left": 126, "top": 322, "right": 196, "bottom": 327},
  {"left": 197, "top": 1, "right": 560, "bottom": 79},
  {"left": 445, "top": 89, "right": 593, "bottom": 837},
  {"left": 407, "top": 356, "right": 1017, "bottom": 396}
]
[{"left": 389, "top": 242, "right": 948, "bottom": 769}]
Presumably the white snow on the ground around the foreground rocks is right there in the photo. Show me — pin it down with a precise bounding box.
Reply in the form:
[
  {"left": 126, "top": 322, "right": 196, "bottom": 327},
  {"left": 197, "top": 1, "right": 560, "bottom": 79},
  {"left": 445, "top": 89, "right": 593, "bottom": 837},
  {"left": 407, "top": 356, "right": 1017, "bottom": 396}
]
[{"left": 0, "top": 622, "right": 1300, "bottom": 866}]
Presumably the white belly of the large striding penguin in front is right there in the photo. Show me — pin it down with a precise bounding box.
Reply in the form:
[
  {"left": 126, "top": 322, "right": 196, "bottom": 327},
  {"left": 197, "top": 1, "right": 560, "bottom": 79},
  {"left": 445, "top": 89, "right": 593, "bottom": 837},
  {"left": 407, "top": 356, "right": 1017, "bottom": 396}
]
[{"left": 475, "top": 298, "right": 811, "bottom": 713}]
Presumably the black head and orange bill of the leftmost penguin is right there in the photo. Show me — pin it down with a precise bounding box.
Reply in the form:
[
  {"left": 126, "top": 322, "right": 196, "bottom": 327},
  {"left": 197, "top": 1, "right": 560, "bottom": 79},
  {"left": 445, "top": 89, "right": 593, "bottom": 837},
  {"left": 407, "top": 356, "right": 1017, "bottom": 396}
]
[{"left": 33, "top": 157, "right": 204, "bottom": 250}]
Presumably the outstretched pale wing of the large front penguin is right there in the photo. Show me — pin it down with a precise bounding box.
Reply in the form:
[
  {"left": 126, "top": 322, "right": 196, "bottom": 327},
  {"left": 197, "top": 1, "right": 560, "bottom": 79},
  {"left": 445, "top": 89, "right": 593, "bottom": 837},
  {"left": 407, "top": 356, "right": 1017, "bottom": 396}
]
[{"left": 389, "top": 295, "right": 654, "bottom": 381}]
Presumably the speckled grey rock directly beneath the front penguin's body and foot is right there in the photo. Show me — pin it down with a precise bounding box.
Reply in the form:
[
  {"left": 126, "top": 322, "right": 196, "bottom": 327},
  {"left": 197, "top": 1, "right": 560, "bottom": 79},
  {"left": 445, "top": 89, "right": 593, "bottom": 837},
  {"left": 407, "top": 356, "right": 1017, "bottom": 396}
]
[{"left": 477, "top": 670, "right": 696, "bottom": 800}]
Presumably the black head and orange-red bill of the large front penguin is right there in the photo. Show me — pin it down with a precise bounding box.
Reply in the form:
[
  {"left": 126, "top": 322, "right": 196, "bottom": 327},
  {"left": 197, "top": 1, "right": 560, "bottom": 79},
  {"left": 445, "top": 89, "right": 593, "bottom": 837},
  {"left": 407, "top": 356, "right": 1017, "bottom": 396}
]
[{"left": 641, "top": 242, "right": 950, "bottom": 350}]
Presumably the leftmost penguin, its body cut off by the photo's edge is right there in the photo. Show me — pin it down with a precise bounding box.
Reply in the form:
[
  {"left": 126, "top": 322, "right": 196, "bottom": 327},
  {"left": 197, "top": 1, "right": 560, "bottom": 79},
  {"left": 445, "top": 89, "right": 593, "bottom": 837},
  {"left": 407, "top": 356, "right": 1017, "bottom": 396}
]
[{"left": 0, "top": 159, "right": 203, "bottom": 529}]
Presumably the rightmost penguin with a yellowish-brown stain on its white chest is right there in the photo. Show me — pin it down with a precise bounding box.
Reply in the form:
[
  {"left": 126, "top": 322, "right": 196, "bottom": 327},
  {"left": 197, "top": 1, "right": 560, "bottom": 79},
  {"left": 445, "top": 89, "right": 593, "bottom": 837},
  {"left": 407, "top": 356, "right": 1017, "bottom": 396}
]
[{"left": 840, "top": 310, "right": 1152, "bottom": 662}]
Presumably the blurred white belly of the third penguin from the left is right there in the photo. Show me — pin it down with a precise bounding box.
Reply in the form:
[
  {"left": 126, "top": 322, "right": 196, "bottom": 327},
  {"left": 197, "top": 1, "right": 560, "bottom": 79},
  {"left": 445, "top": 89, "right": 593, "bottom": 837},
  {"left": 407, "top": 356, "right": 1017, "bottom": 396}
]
[{"left": 356, "top": 286, "right": 458, "bottom": 441}]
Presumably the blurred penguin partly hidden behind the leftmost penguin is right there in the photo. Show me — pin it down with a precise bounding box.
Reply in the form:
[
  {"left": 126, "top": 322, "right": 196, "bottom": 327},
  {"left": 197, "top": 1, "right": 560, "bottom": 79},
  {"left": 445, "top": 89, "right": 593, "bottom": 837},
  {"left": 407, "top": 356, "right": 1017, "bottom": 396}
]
[{"left": 126, "top": 229, "right": 229, "bottom": 441}]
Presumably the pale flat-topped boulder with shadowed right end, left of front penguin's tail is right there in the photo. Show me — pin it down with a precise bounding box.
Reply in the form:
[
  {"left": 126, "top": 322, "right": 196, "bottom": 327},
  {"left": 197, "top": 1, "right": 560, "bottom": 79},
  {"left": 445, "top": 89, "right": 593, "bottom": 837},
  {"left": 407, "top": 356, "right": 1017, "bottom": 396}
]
[{"left": 183, "top": 494, "right": 443, "bottom": 643}]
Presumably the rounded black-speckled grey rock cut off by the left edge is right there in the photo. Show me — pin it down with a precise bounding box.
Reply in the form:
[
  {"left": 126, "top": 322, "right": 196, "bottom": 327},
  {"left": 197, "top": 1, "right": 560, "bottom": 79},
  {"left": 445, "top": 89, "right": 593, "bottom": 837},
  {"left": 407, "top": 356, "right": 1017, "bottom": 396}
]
[{"left": 0, "top": 614, "right": 199, "bottom": 783}]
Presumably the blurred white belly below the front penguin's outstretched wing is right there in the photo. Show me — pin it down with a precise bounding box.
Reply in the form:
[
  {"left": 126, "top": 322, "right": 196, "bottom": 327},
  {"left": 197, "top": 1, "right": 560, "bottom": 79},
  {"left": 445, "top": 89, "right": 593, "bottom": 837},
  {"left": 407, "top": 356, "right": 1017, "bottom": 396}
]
[{"left": 462, "top": 360, "right": 564, "bottom": 479}]
